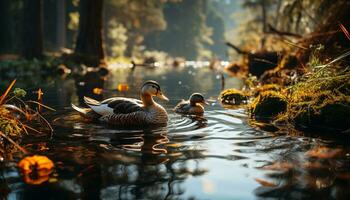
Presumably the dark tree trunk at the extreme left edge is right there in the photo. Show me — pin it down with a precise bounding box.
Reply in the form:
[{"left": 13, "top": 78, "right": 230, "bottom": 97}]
[{"left": 0, "top": 0, "right": 12, "bottom": 54}]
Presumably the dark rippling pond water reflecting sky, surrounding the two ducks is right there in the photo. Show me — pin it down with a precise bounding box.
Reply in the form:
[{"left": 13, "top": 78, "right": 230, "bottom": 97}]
[{"left": 0, "top": 67, "right": 350, "bottom": 199}]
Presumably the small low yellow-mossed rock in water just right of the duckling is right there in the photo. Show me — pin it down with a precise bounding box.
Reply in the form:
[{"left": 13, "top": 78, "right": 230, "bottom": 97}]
[{"left": 219, "top": 88, "right": 248, "bottom": 105}]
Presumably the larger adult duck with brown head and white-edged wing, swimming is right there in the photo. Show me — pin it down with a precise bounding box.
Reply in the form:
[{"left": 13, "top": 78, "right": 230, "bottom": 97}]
[{"left": 72, "top": 80, "right": 169, "bottom": 126}]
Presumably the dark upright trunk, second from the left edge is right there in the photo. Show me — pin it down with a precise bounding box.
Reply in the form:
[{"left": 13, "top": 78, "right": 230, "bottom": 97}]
[{"left": 23, "top": 0, "right": 43, "bottom": 59}]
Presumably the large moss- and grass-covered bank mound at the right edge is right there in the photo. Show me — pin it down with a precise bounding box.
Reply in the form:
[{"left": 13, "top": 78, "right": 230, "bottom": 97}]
[{"left": 281, "top": 60, "right": 350, "bottom": 131}]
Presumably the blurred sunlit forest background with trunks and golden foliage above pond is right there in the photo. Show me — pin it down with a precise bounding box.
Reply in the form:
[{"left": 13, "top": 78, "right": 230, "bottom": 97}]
[{"left": 0, "top": 0, "right": 349, "bottom": 66}]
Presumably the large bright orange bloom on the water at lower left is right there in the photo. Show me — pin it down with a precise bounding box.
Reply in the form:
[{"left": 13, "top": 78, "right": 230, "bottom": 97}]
[{"left": 18, "top": 155, "right": 54, "bottom": 185}]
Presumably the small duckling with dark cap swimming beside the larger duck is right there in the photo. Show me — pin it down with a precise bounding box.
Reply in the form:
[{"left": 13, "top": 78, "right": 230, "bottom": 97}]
[{"left": 174, "top": 93, "right": 208, "bottom": 115}]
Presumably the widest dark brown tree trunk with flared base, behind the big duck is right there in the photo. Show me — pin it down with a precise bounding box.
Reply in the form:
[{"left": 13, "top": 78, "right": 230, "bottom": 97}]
[{"left": 75, "top": 0, "right": 105, "bottom": 67}]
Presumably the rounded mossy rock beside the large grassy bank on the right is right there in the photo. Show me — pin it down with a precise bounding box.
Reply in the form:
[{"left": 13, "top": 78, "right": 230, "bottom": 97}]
[{"left": 250, "top": 91, "right": 287, "bottom": 120}]
